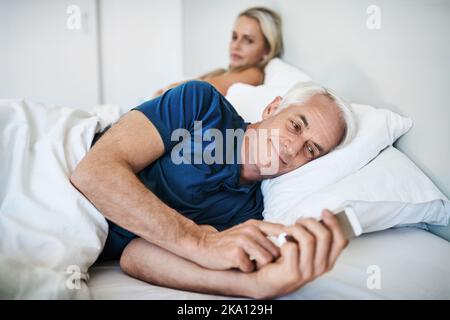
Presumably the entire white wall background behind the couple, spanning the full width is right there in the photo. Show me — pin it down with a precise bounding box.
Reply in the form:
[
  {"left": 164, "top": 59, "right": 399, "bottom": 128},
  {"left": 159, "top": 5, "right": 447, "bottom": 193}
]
[{"left": 0, "top": 0, "right": 450, "bottom": 200}]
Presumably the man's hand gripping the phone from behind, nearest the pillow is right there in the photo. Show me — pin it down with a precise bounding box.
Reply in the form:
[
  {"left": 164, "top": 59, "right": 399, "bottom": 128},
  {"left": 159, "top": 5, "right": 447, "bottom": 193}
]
[{"left": 253, "top": 210, "right": 348, "bottom": 298}]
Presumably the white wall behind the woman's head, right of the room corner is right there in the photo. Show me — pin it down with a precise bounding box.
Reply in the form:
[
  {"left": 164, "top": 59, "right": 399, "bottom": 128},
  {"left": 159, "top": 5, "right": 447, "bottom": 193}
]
[{"left": 184, "top": 0, "right": 450, "bottom": 200}]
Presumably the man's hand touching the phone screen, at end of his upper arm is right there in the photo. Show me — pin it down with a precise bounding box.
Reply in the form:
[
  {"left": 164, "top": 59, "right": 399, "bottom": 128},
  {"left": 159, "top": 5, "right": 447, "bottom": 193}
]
[{"left": 193, "top": 220, "right": 285, "bottom": 272}]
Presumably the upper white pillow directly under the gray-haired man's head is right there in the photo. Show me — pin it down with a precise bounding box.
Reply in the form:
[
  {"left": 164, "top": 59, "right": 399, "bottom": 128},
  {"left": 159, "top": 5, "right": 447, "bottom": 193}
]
[{"left": 261, "top": 104, "right": 412, "bottom": 215}]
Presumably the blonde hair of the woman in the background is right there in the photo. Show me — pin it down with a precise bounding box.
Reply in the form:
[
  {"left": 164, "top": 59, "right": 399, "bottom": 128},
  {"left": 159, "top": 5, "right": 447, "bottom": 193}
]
[{"left": 238, "top": 7, "right": 284, "bottom": 68}]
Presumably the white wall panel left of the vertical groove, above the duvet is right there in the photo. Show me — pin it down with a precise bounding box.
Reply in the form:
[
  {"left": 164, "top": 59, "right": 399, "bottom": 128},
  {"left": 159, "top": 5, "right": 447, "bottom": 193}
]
[{"left": 0, "top": 0, "right": 98, "bottom": 108}]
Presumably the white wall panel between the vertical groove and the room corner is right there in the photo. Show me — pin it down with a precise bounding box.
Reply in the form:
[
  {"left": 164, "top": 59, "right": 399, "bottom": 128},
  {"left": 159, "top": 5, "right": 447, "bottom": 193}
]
[{"left": 100, "top": 0, "right": 183, "bottom": 110}]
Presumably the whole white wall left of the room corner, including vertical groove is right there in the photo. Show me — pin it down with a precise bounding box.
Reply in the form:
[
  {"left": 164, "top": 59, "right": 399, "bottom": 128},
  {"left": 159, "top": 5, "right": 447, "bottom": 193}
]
[{"left": 0, "top": 0, "right": 183, "bottom": 110}]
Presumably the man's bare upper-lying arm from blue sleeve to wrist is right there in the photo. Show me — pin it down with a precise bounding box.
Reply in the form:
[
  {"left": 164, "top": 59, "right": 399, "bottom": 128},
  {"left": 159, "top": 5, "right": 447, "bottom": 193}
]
[{"left": 70, "top": 111, "right": 203, "bottom": 254}]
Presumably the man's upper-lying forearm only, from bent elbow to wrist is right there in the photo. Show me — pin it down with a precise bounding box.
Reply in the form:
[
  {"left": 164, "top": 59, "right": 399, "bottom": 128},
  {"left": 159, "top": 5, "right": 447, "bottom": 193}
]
[{"left": 71, "top": 160, "right": 204, "bottom": 257}]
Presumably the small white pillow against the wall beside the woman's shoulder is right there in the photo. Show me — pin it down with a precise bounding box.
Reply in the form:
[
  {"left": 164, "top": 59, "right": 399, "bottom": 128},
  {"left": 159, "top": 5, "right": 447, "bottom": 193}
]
[{"left": 264, "top": 58, "right": 312, "bottom": 88}]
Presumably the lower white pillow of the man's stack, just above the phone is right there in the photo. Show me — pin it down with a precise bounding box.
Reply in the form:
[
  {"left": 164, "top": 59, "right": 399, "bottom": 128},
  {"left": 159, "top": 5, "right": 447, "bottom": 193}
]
[{"left": 264, "top": 147, "right": 450, "bottom": 238}]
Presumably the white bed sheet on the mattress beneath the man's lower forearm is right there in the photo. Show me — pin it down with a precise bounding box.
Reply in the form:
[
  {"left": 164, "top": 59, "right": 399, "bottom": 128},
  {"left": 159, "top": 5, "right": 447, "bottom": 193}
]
[{"left": 88, "top": 228, "right": 450, "bottom": 300}]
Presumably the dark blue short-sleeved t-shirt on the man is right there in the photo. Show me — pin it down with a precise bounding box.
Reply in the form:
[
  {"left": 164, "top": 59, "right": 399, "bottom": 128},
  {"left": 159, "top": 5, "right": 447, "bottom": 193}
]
[{"left": 134, "top": 81, "right": 264, "bottom": 230}]
